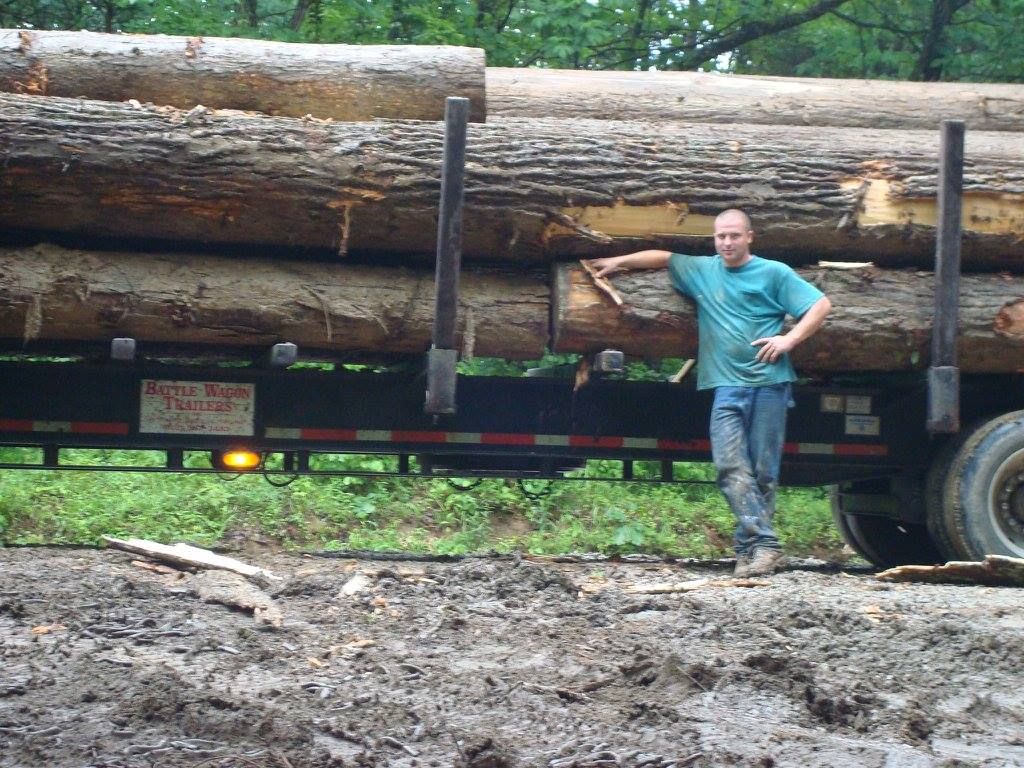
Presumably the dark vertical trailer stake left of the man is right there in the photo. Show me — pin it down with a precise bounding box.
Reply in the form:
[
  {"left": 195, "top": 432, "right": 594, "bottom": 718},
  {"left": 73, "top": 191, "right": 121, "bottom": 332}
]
[{"left": 423, "top": 96, "right": 469, "bottom": 416}]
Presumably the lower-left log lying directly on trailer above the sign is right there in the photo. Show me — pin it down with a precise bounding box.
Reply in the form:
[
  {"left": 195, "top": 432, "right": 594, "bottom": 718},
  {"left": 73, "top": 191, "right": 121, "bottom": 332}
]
[{"left": 0, "top": 245, "right": 549, "bottom": 359}]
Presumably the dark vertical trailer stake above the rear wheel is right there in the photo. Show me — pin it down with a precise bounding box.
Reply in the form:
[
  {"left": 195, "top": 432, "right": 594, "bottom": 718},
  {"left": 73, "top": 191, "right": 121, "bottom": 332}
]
[{"left": 928, "top": 120, "right": 964, "bottom": 434}]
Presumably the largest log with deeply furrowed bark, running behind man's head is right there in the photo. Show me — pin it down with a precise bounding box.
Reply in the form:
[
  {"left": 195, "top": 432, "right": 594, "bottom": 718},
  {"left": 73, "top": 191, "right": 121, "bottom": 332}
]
[{"left": 6, "top": 94, "right": 1024, "bottom": 269}]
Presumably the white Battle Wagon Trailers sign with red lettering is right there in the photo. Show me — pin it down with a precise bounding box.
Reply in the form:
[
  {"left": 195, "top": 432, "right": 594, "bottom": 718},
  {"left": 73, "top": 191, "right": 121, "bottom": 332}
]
[{"left": 138, "top": 379, "right": 255, "bottom": 436}]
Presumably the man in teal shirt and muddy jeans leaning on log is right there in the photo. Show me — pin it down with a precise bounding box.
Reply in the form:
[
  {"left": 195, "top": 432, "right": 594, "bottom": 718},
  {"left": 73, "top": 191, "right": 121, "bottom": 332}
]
[{"left": 591, "top": 209, "right": 831, "bottom": 577}]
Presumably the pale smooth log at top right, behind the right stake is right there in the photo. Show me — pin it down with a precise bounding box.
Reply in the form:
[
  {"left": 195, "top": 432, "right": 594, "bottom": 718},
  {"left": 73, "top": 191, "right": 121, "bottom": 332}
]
[{"left": 486, "top": 67, "right": 1024, "bottom": 131}]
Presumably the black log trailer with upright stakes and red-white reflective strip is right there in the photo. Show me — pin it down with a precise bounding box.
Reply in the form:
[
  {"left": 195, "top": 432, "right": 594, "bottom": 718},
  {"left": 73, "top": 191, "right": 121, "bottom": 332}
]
[{"left": 0, "top": 99, "right": 1024, "bottom": 566}]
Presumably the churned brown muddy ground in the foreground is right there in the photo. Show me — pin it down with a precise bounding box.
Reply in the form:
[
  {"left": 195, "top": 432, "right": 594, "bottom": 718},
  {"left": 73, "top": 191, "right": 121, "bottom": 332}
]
[{"left": 0, "top": 549, "right": 1024, "bottom": 768}]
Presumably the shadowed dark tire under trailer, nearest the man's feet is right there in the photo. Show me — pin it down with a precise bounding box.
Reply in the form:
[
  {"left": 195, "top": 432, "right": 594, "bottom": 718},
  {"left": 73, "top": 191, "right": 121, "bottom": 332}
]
[{"left": 830, "top": 485, "right": 943, "bottom": 568}]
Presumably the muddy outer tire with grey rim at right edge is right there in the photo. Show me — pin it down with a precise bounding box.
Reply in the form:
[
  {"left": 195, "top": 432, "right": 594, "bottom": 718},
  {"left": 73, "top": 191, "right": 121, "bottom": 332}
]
[{"left": 942, "top": 411, "right": 1024, "bottom": 560}]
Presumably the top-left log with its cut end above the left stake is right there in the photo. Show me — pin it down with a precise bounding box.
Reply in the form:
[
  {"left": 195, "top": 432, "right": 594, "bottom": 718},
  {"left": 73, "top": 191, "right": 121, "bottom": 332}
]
[{"left": 0, "top": 30, "right": 486, "bottom": 122}]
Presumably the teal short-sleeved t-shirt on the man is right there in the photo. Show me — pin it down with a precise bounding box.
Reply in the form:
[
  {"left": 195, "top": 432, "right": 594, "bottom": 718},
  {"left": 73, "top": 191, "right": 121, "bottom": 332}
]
[{"left": 669, "top": 253, "right": 824, "bottom": 389}]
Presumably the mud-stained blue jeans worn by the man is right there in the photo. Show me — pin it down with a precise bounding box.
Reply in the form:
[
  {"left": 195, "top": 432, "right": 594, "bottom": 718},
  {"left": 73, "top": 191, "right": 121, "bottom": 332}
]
[{"left": 711, "top": 384, "right": 793, "bottom": 555}]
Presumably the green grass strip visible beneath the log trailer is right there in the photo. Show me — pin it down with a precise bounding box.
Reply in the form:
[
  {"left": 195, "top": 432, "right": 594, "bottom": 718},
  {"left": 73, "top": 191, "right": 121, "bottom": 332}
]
[{"left": 0, "top": 449, "right": 842, "bottom": 557}]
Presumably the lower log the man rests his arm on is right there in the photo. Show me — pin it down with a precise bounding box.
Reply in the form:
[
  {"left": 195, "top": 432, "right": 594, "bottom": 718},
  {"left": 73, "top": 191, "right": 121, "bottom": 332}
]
[{"left": 552, "top": 264, "right": 1024, "bottom": 373}]
